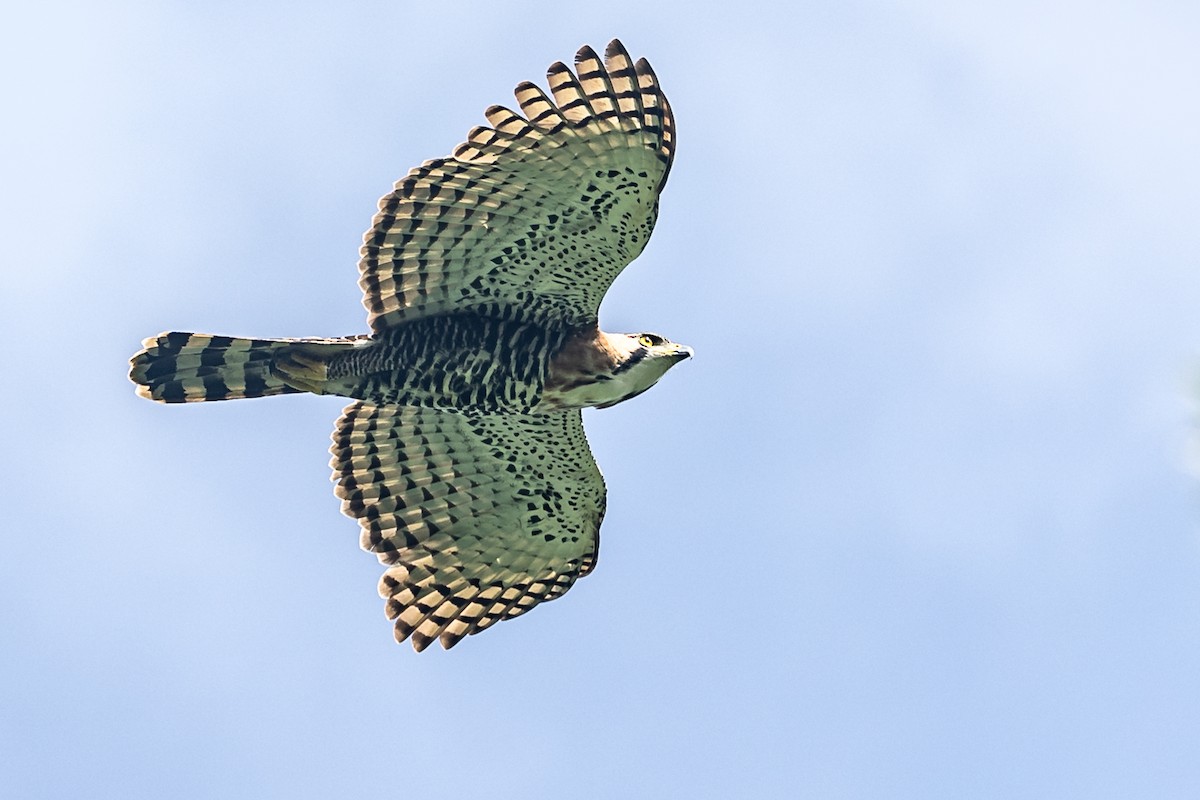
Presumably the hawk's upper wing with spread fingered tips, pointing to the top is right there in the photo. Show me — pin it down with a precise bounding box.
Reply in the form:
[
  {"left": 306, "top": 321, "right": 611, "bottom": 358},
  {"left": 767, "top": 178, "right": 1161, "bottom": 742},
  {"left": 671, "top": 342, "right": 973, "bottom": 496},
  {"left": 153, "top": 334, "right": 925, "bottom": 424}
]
[{"left": 359, "top": 40, "right": 674, "bottom": 331}]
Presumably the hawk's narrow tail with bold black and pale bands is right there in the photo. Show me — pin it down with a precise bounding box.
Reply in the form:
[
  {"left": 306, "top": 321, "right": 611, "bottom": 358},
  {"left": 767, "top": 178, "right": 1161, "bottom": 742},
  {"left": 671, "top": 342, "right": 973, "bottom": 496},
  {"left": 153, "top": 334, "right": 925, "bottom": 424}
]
[{"left": 130, "top": 331, "right": 368, "bottom": 403}]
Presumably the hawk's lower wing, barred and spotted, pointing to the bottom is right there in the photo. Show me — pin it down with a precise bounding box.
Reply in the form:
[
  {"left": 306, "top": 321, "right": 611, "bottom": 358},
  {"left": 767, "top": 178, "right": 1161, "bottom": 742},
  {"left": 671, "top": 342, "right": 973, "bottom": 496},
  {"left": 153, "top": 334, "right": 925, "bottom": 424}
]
[{"left": 331, "top": 403, "right": 605, "bottom": 650}]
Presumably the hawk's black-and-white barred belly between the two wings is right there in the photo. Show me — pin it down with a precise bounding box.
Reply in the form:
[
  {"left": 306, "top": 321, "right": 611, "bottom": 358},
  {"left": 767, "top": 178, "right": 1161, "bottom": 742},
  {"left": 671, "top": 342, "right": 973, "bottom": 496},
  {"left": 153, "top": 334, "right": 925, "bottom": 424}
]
[{"left": 326, "top": 313, "right": 566, "bottom": 414}]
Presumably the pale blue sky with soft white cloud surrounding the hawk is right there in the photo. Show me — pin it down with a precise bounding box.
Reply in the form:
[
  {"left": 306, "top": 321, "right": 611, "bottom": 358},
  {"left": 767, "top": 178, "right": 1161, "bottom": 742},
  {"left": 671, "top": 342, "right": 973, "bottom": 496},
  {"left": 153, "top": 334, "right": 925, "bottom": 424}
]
[{"left": 0, "top": 0, "right": 1200, "bottom": 799}]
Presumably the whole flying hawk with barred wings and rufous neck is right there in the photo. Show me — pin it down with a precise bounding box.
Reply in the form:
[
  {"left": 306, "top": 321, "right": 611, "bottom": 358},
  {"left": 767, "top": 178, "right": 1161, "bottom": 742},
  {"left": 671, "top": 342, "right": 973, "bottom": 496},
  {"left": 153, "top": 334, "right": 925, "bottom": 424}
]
[{"left": 130, "top": 40, "right": 691, "bottom": 651}]
